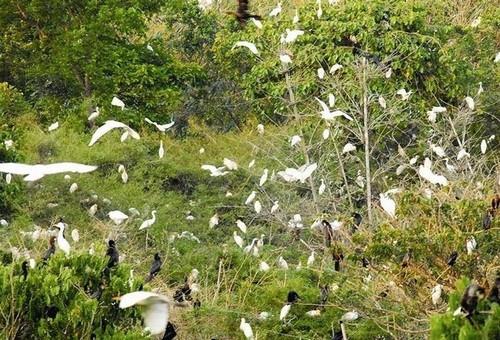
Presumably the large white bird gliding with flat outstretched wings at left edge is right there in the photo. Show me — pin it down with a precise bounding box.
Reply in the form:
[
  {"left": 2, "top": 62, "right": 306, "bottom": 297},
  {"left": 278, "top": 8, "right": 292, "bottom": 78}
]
[{"left": 0, "top": 162, "right": 97, "bottom": 182}]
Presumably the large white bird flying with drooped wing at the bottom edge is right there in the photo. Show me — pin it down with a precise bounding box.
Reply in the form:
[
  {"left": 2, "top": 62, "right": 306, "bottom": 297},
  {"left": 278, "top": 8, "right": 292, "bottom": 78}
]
[{"left": 119, "top": 291, "right": 169, "bottom": 335}]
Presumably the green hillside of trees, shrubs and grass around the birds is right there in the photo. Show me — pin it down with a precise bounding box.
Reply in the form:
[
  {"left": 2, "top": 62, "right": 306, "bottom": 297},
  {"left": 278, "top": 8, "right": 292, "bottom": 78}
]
[{"left": 0, "top": 1, "right": 500, "bottom": 339}]
